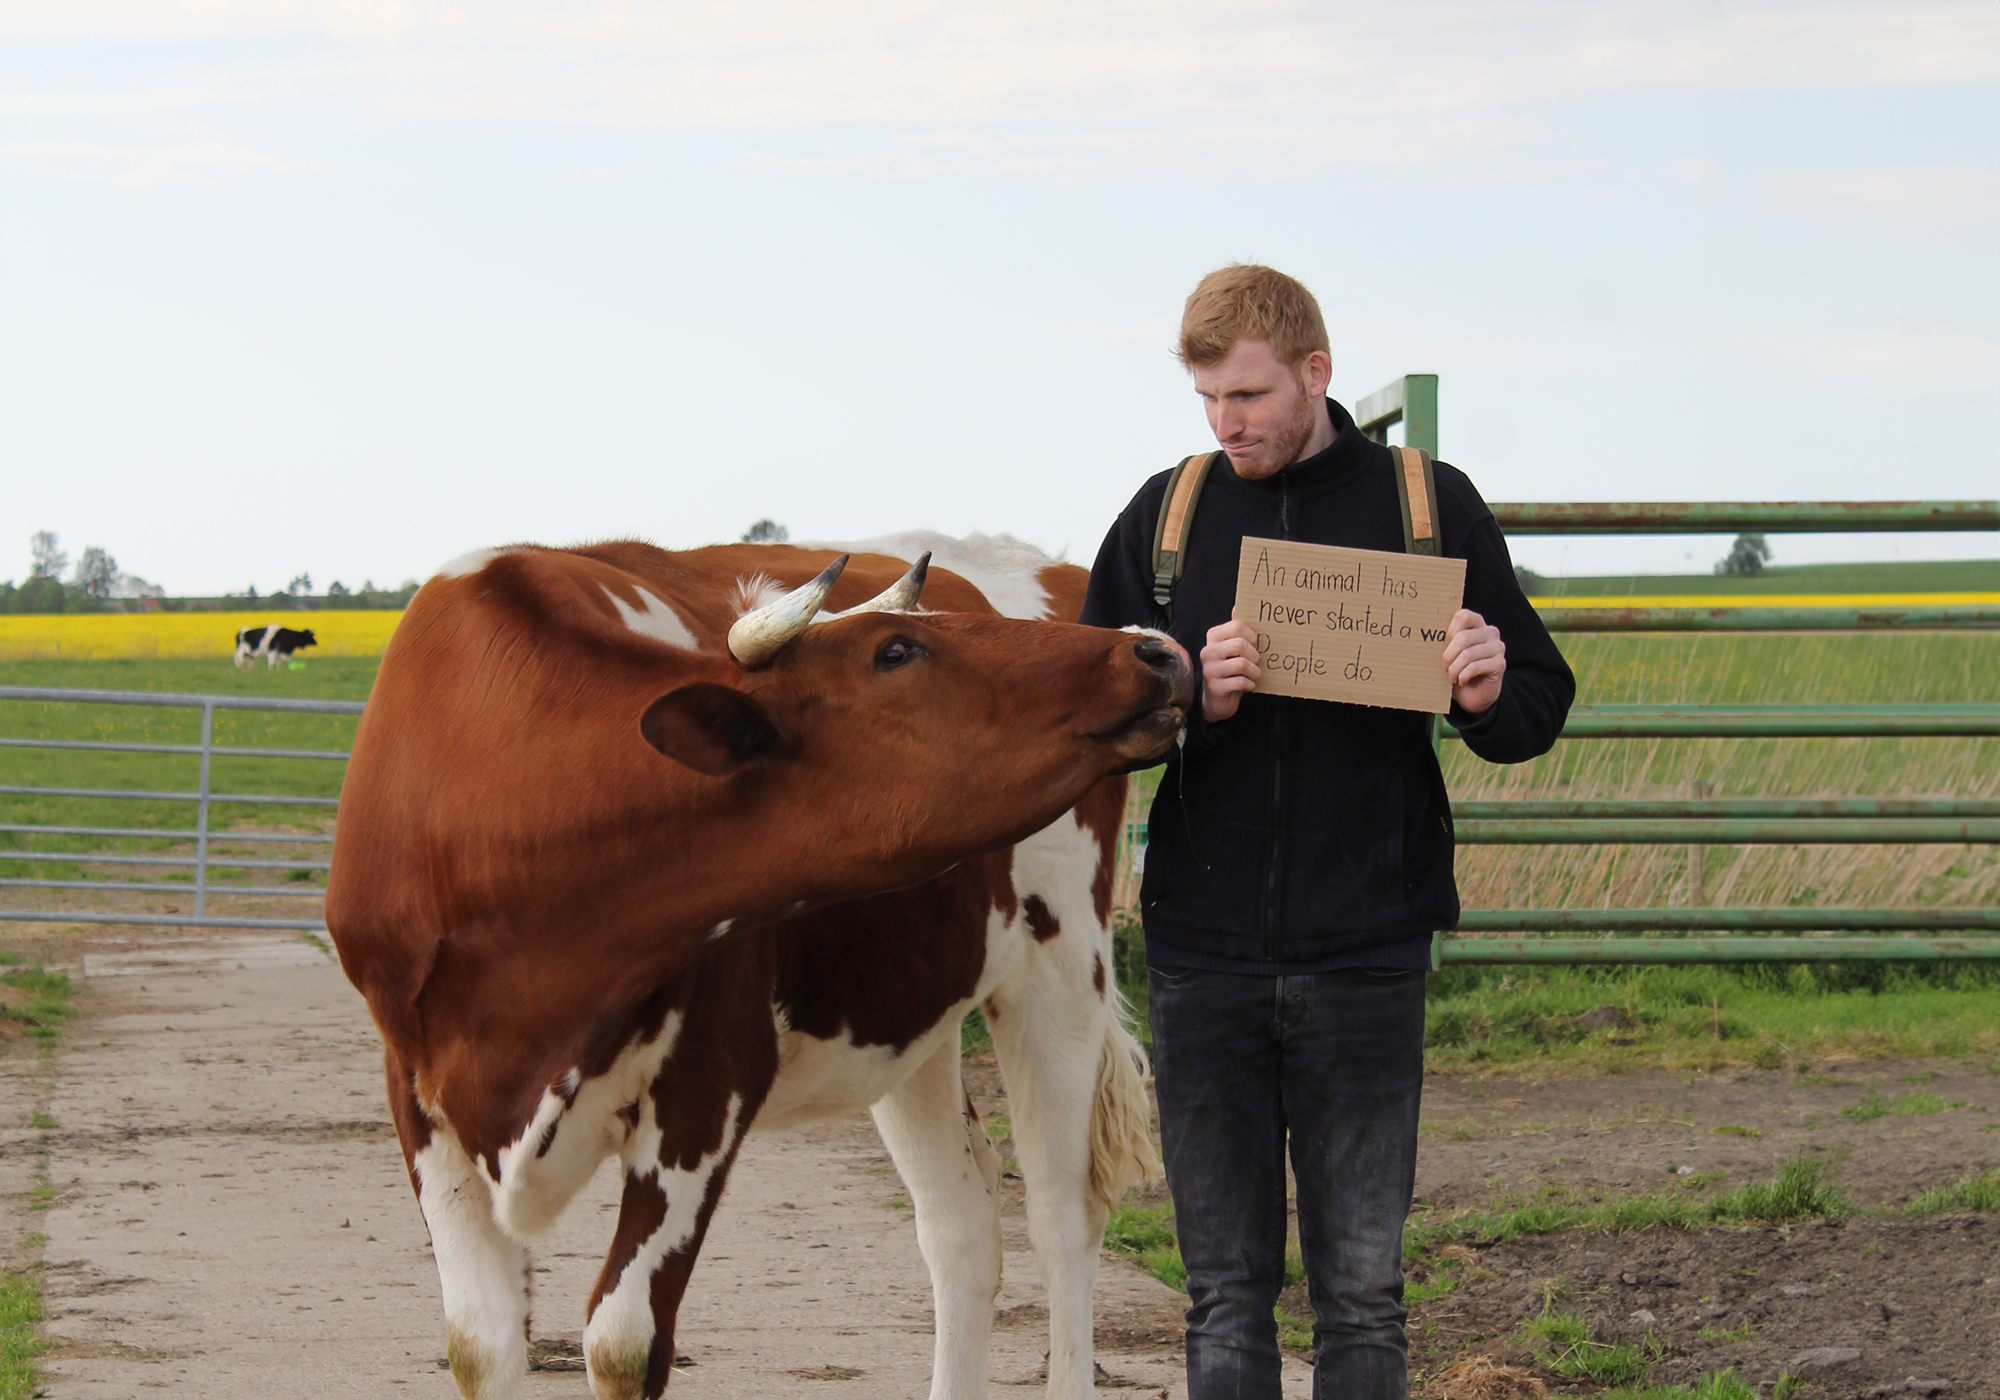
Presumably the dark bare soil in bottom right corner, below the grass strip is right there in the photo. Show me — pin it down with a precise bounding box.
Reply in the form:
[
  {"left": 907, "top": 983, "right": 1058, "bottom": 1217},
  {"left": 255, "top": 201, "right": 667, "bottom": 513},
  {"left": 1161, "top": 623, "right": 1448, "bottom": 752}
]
[{"left": 1410, "top": 1216, "right": 2000, "bottom": 1400}]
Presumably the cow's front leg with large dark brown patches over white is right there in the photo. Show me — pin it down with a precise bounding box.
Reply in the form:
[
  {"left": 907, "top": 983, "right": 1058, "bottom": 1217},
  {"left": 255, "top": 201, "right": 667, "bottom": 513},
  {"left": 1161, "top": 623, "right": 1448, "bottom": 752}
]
[{"left": 584, "top": 964, "right": 778, "bottom": 1400}]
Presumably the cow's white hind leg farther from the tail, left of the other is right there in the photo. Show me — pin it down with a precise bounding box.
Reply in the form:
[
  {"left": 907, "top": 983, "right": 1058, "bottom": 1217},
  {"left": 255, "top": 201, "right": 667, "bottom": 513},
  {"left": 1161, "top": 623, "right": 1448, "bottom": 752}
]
[{"left": 872, "top": 1030, "right": 1000, "bottom": 1400}]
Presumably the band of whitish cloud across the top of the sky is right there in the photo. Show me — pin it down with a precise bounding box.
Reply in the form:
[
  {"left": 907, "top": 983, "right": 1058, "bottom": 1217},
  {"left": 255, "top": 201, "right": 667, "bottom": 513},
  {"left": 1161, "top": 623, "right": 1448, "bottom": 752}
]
[{"left": 0, "top": 0, "right": 2000, "bottom": 176}]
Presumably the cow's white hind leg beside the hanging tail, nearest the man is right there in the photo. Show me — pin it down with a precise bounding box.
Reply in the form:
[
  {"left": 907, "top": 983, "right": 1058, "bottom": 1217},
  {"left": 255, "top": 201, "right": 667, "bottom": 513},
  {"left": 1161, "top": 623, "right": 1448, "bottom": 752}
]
[{"left": 988, "top": 948, "right": 1110, "bottom": 1400}]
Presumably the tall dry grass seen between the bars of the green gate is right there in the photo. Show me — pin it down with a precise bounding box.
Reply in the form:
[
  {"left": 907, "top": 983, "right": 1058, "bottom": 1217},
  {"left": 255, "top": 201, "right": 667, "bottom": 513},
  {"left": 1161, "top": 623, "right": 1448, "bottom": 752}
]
[{"left": 1444, "top": 634, "right": 2000, "bottom": 908}]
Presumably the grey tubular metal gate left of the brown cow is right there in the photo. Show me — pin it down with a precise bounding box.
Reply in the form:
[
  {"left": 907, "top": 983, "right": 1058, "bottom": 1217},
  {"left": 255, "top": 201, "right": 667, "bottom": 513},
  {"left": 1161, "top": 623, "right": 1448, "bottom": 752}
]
[{"left": 0, "top": 686, "right": 362, "bottom": 930}]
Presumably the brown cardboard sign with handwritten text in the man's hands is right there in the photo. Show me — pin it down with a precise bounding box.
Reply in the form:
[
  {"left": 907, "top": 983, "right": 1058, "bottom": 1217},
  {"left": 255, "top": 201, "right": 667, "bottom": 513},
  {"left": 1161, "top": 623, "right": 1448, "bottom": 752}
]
[{"left": 1236, "top": 536, "right": 1466, "bottom": 714}]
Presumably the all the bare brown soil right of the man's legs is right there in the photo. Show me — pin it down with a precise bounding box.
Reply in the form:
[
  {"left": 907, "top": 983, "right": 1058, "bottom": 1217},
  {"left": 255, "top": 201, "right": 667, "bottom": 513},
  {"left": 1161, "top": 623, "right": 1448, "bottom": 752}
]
[{"left": 1280, "top": 1060, "right": 2000, "bottom": 1400}]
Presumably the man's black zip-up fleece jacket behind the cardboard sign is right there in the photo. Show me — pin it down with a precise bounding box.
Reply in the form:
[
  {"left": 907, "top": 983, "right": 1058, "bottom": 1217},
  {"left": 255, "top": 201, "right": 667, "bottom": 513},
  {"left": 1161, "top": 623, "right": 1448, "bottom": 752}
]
[{"left": 1080, "top": 400, "right": 1576, "bottom": 972}]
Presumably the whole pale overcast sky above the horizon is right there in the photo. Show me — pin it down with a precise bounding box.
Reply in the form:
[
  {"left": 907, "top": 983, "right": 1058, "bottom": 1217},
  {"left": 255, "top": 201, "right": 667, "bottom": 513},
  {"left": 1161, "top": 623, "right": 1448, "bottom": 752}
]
[{"left": 0, "top": 0, "right": 2000, "bottom": 592}]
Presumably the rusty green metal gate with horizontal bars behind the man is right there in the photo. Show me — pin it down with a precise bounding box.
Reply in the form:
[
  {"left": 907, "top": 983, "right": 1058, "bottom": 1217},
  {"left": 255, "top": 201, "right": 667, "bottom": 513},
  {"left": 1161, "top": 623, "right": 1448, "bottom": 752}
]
[{"left": 1354, "top": 374, "right": 2000, "bottom": 966}]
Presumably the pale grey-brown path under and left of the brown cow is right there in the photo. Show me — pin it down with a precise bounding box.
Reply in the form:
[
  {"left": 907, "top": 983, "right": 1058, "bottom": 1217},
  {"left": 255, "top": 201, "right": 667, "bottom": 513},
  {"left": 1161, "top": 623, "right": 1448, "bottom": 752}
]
[{"left": 23, "top": 938, "right": 1240, "bottom": 1400}]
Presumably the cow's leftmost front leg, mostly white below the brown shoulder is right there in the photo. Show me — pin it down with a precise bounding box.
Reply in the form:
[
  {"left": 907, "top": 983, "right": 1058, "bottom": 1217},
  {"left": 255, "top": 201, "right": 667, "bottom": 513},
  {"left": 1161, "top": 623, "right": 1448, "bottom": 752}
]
[{"left": 386, "top": 1052, "right": 532, "bottom": 1400}]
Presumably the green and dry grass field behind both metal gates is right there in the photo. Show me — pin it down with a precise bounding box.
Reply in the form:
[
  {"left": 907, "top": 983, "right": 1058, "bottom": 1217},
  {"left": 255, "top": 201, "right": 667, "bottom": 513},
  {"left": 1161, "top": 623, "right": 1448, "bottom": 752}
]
[{"left": 15, "top": 634, "right": 2000, "bottom": 1072}]
